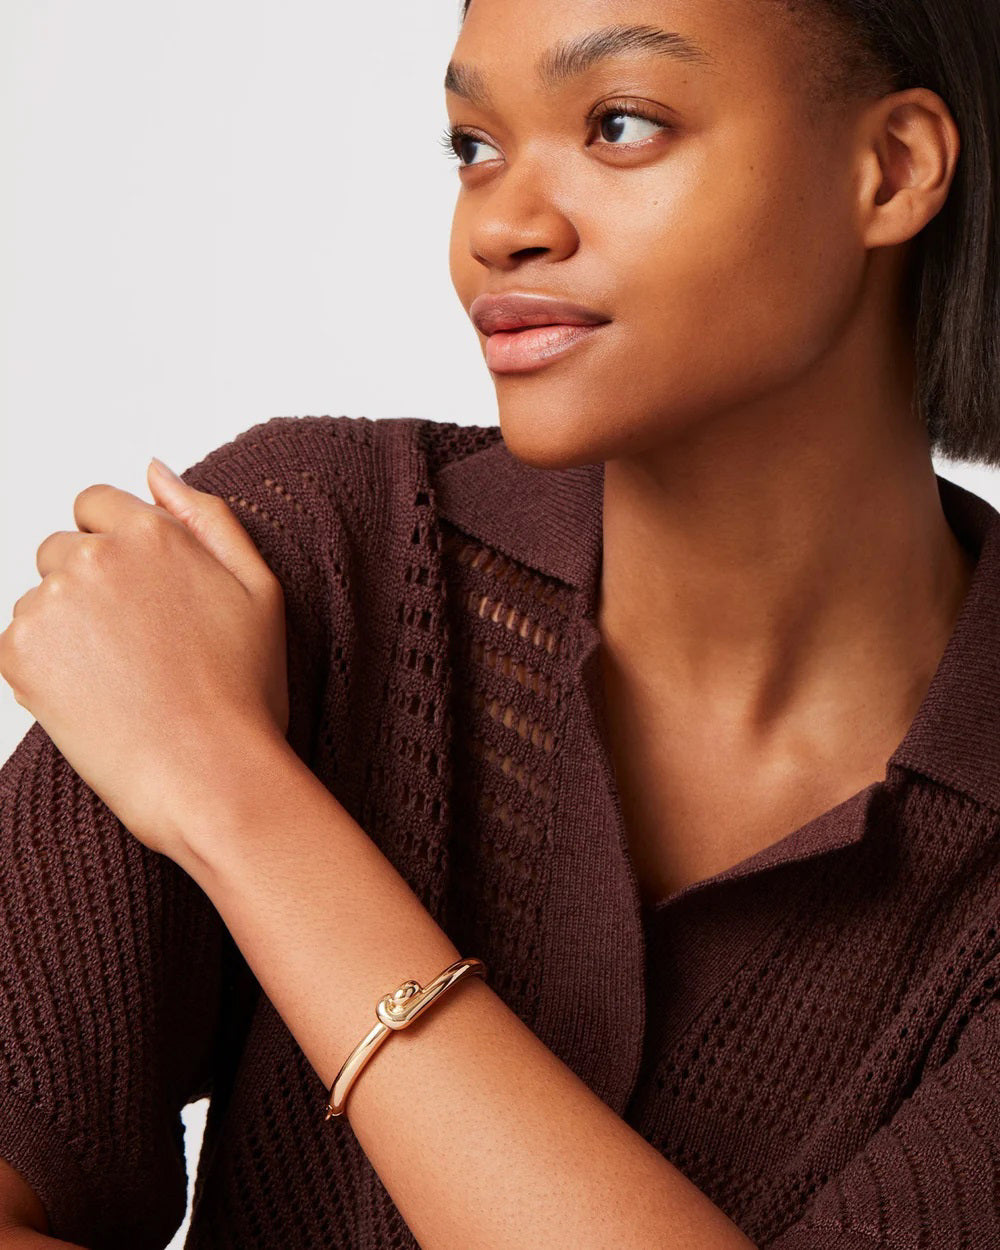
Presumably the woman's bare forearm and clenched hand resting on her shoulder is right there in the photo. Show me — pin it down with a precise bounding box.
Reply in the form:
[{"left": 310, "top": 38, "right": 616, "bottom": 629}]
[{"left": 0, "top": 470, "right": 751, "bottom": 1250}]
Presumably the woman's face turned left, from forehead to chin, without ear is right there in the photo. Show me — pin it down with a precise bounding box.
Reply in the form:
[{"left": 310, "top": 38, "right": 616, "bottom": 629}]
[{"left": 446, "top": 0, "right": 885, "bottom": 466}]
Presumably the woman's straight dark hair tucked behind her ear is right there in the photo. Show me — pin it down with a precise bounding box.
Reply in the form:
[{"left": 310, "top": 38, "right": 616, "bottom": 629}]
[{"left": 460, "top": 0, "right": 1000, "bottom": 468}]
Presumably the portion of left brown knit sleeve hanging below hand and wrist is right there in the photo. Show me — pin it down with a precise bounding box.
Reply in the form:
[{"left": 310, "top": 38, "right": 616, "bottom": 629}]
[{"left": 0, "top": 721, "right": 223, "bottom": 1250}]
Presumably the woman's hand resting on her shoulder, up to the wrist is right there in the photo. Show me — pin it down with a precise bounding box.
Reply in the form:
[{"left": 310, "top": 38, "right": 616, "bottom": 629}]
[{"left": 0, "top": 461, "right": 289, "bottom": 859}]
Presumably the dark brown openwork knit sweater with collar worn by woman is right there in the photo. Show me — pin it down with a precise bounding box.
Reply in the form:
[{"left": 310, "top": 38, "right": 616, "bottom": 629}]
[{"left": 0, "top": 416, "right": 1000, "bottom": 1250}]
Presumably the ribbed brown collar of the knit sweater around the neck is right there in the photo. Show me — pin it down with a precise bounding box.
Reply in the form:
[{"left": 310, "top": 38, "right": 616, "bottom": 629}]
[{"left": 435, "top": 428, "right": 1000, "bottom": 810}]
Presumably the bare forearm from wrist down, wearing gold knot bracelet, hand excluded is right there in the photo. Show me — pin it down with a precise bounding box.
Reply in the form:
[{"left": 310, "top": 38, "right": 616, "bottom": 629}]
[{"left": 181, "top": 748, "right": 753, "bottom": 1250}]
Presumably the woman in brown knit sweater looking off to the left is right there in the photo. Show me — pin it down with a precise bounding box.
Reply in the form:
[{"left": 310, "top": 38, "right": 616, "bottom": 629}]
[{"left": 0, "top": 0, "right": 1000, "bottom": 1250}]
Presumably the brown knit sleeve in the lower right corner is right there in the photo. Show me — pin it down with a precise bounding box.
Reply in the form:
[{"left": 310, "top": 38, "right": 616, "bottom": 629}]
[{"left": 761, "top": 975, "right": 1000, "bottom": 1250}]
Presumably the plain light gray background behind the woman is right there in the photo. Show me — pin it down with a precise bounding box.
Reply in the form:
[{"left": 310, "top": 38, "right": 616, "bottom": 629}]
[{"left": 0, "top": 0, "right": 1000, "bottom": 1246}]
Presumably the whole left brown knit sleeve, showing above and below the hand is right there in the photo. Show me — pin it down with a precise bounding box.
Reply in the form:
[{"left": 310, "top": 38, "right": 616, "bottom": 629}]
[{"left": 0, "top": 418, "right": 363, "bottom": 1250}]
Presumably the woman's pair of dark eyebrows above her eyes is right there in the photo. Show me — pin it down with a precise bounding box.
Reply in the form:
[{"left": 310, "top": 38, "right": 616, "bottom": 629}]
[{"left": 445, "top": 26, "right": 714, "bottom": 108}]
